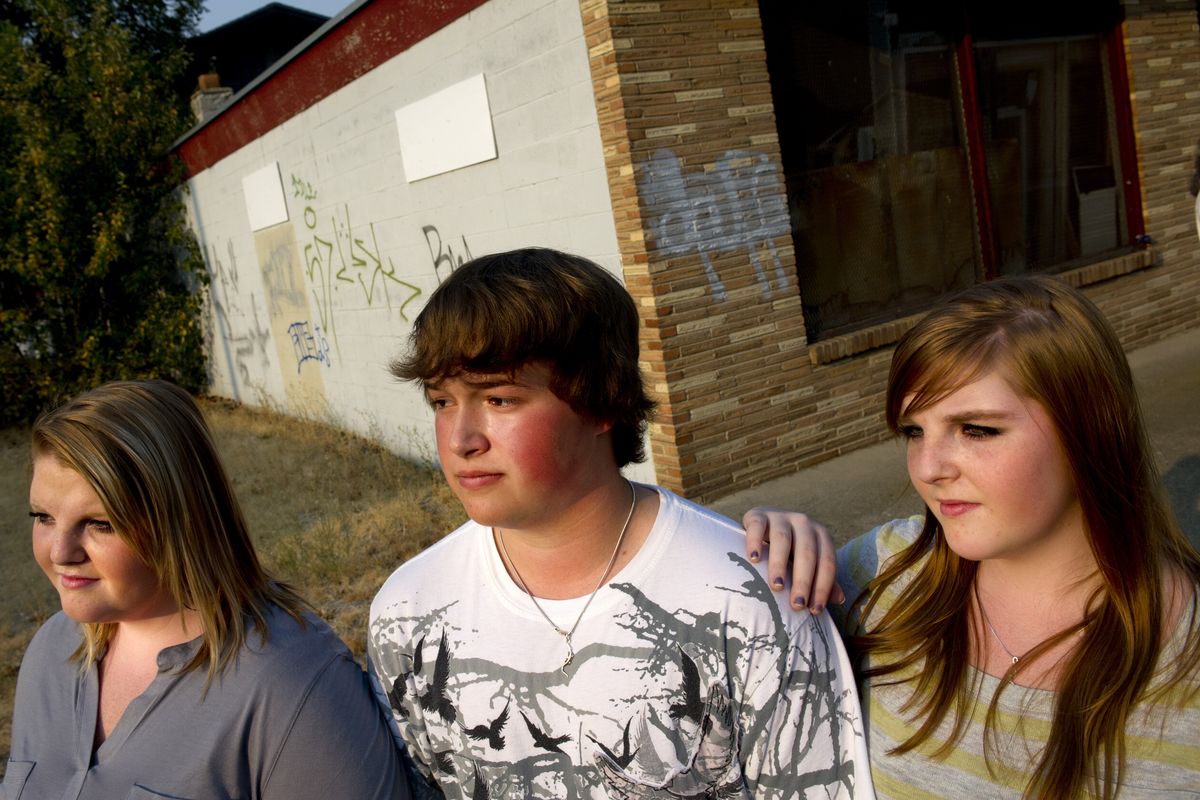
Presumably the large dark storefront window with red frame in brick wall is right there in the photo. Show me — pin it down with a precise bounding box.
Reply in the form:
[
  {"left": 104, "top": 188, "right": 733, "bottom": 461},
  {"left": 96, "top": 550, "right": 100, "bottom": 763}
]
[{"left": 761, "top": 0, "right": 1130, "bottom": 341}]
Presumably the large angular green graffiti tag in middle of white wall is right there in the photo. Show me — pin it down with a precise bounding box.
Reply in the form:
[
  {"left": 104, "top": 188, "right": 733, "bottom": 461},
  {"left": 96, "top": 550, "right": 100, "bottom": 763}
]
[{"left": 292, "top": 175, "right": 421, "bottom": 351}]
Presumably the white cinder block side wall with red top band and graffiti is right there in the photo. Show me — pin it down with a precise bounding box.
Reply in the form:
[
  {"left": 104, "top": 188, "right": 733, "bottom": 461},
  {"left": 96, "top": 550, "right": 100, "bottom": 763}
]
[{"left": 187, "top": 0, "right": 653, "bottom": 480}]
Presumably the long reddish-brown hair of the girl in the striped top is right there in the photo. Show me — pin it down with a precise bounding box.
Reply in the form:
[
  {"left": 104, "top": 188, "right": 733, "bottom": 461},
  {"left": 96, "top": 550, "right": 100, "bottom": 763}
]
[{"left": 851, "top": 277, "right": 1200, "bottom": 798}]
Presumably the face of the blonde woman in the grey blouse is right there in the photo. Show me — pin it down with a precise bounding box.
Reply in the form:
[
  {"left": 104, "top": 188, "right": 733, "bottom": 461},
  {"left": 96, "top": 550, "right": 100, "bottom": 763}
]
[{"left": 29, "top": 456, "right": 178, "bottom": 622}]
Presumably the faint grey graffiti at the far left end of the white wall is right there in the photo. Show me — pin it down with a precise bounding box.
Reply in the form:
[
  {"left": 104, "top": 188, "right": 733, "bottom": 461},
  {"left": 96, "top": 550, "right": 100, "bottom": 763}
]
[{"left": 204, "top": 240, "right": 271, "bottom": 401}]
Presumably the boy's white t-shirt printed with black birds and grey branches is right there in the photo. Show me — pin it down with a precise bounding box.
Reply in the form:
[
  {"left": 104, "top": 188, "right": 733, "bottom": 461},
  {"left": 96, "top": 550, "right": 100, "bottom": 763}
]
[{"left": 368, "top": 489, "right": 874, "bottom": 799}]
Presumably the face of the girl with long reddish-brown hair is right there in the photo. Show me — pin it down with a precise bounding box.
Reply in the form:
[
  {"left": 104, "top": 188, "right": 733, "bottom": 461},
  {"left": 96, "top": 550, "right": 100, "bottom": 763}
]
[{"left": 900, "top": 369, "right": 1087, "bottom": 561}]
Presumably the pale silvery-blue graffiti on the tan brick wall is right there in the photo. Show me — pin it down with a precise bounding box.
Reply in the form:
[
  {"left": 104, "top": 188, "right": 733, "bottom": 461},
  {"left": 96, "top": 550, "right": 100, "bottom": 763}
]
[{"left": 638, "top": 149, "right": 791, "bottom": 302}]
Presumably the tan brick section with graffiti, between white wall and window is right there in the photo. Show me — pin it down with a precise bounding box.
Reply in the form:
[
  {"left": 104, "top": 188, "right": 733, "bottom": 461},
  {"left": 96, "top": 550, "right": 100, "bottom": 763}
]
[{"left": 581, "top": 0, "right": 902, "bottom": 499}]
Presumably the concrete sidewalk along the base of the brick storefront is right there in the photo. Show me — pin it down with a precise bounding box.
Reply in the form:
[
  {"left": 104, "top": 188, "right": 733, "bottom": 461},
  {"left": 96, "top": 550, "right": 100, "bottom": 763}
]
[{"left": 712, "top": 329, "right": 1200, "bottom": 547}]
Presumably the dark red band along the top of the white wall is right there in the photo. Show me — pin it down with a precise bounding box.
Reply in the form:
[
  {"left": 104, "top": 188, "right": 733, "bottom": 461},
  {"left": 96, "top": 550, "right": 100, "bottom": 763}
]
[{"left": 175, "top": 0, "right": 487, "bottom": 178}]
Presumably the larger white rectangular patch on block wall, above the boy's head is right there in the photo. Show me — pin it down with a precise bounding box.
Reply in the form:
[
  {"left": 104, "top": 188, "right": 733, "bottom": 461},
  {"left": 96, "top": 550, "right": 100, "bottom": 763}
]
[{"left": 396, "top": 74, "right": 496, "bottom": 184}]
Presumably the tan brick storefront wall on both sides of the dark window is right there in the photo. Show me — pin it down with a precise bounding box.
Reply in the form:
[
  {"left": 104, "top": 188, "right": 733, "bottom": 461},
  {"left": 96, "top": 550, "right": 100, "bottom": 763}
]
[{"left": 580, "top": 0, "right": 1200, "bottom": 500}]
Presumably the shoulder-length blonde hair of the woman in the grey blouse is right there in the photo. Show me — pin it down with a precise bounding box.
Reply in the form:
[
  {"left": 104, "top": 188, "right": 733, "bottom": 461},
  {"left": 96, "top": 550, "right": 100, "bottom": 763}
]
[{"left": 32, "top": 380, "right": 307, "bottom": 682}]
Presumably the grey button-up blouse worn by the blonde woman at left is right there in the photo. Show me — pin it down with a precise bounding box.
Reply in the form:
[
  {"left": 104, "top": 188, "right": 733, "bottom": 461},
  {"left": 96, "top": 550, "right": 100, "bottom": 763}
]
[{"left": 0, "top": 609, "right": 408, "bottom": 800}]
